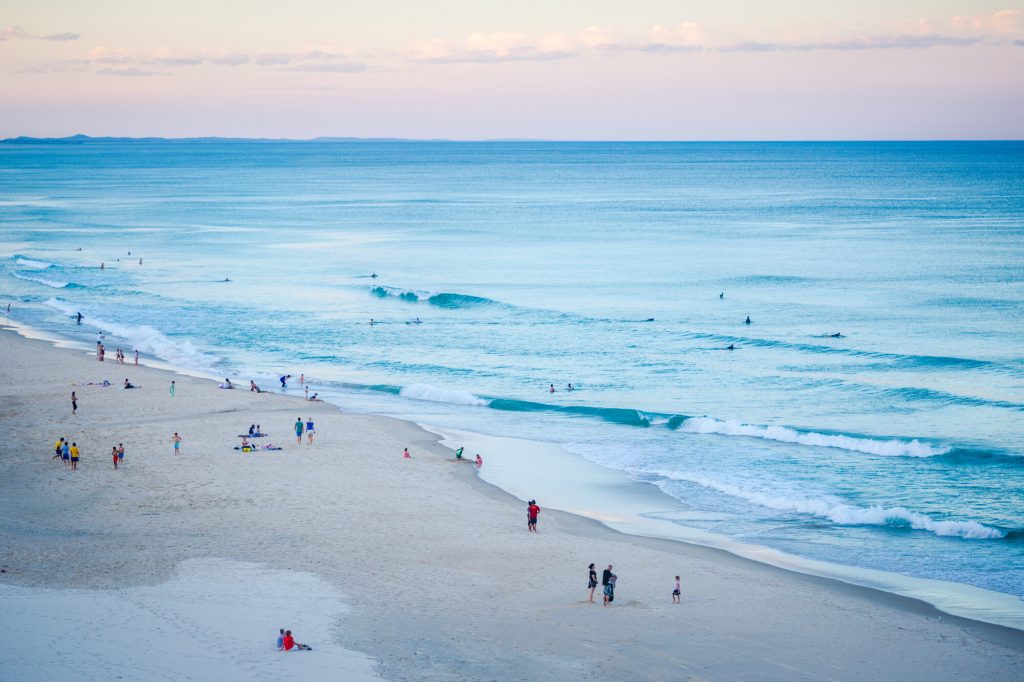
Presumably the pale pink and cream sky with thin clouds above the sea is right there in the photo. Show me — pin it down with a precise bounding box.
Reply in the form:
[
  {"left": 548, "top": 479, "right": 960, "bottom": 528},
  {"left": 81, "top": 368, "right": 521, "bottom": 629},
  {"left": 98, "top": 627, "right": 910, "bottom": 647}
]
[{"left": 0, "top": 0, "right": 1024, "bottom": 140}]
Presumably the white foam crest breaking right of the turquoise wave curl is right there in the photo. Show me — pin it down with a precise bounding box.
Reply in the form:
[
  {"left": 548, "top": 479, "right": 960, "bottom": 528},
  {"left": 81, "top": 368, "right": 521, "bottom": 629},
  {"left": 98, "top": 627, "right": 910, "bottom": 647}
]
[{"left": 679, "top": 417, "right": 950, "bottom": 457}]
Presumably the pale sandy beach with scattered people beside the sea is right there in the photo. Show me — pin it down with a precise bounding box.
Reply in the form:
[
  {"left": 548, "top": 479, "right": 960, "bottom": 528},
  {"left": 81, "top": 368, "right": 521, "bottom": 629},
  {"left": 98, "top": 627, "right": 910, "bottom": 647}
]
[{"left": 0, "top": 330, "right": 1024, "bottom": 680}]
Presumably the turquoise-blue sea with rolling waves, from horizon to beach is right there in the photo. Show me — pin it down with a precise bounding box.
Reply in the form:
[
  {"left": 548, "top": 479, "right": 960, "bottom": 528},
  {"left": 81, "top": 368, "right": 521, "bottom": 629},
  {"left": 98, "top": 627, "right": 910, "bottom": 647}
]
[{"left": 0, "top": 141, "right": 1024, "bottom": 595}]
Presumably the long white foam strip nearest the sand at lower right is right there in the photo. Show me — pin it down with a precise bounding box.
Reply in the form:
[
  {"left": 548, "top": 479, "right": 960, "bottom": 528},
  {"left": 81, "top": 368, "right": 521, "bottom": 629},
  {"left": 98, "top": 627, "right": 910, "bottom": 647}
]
[{"left": 654, "top": 471, "right": 1006, "bottom": 540}]
